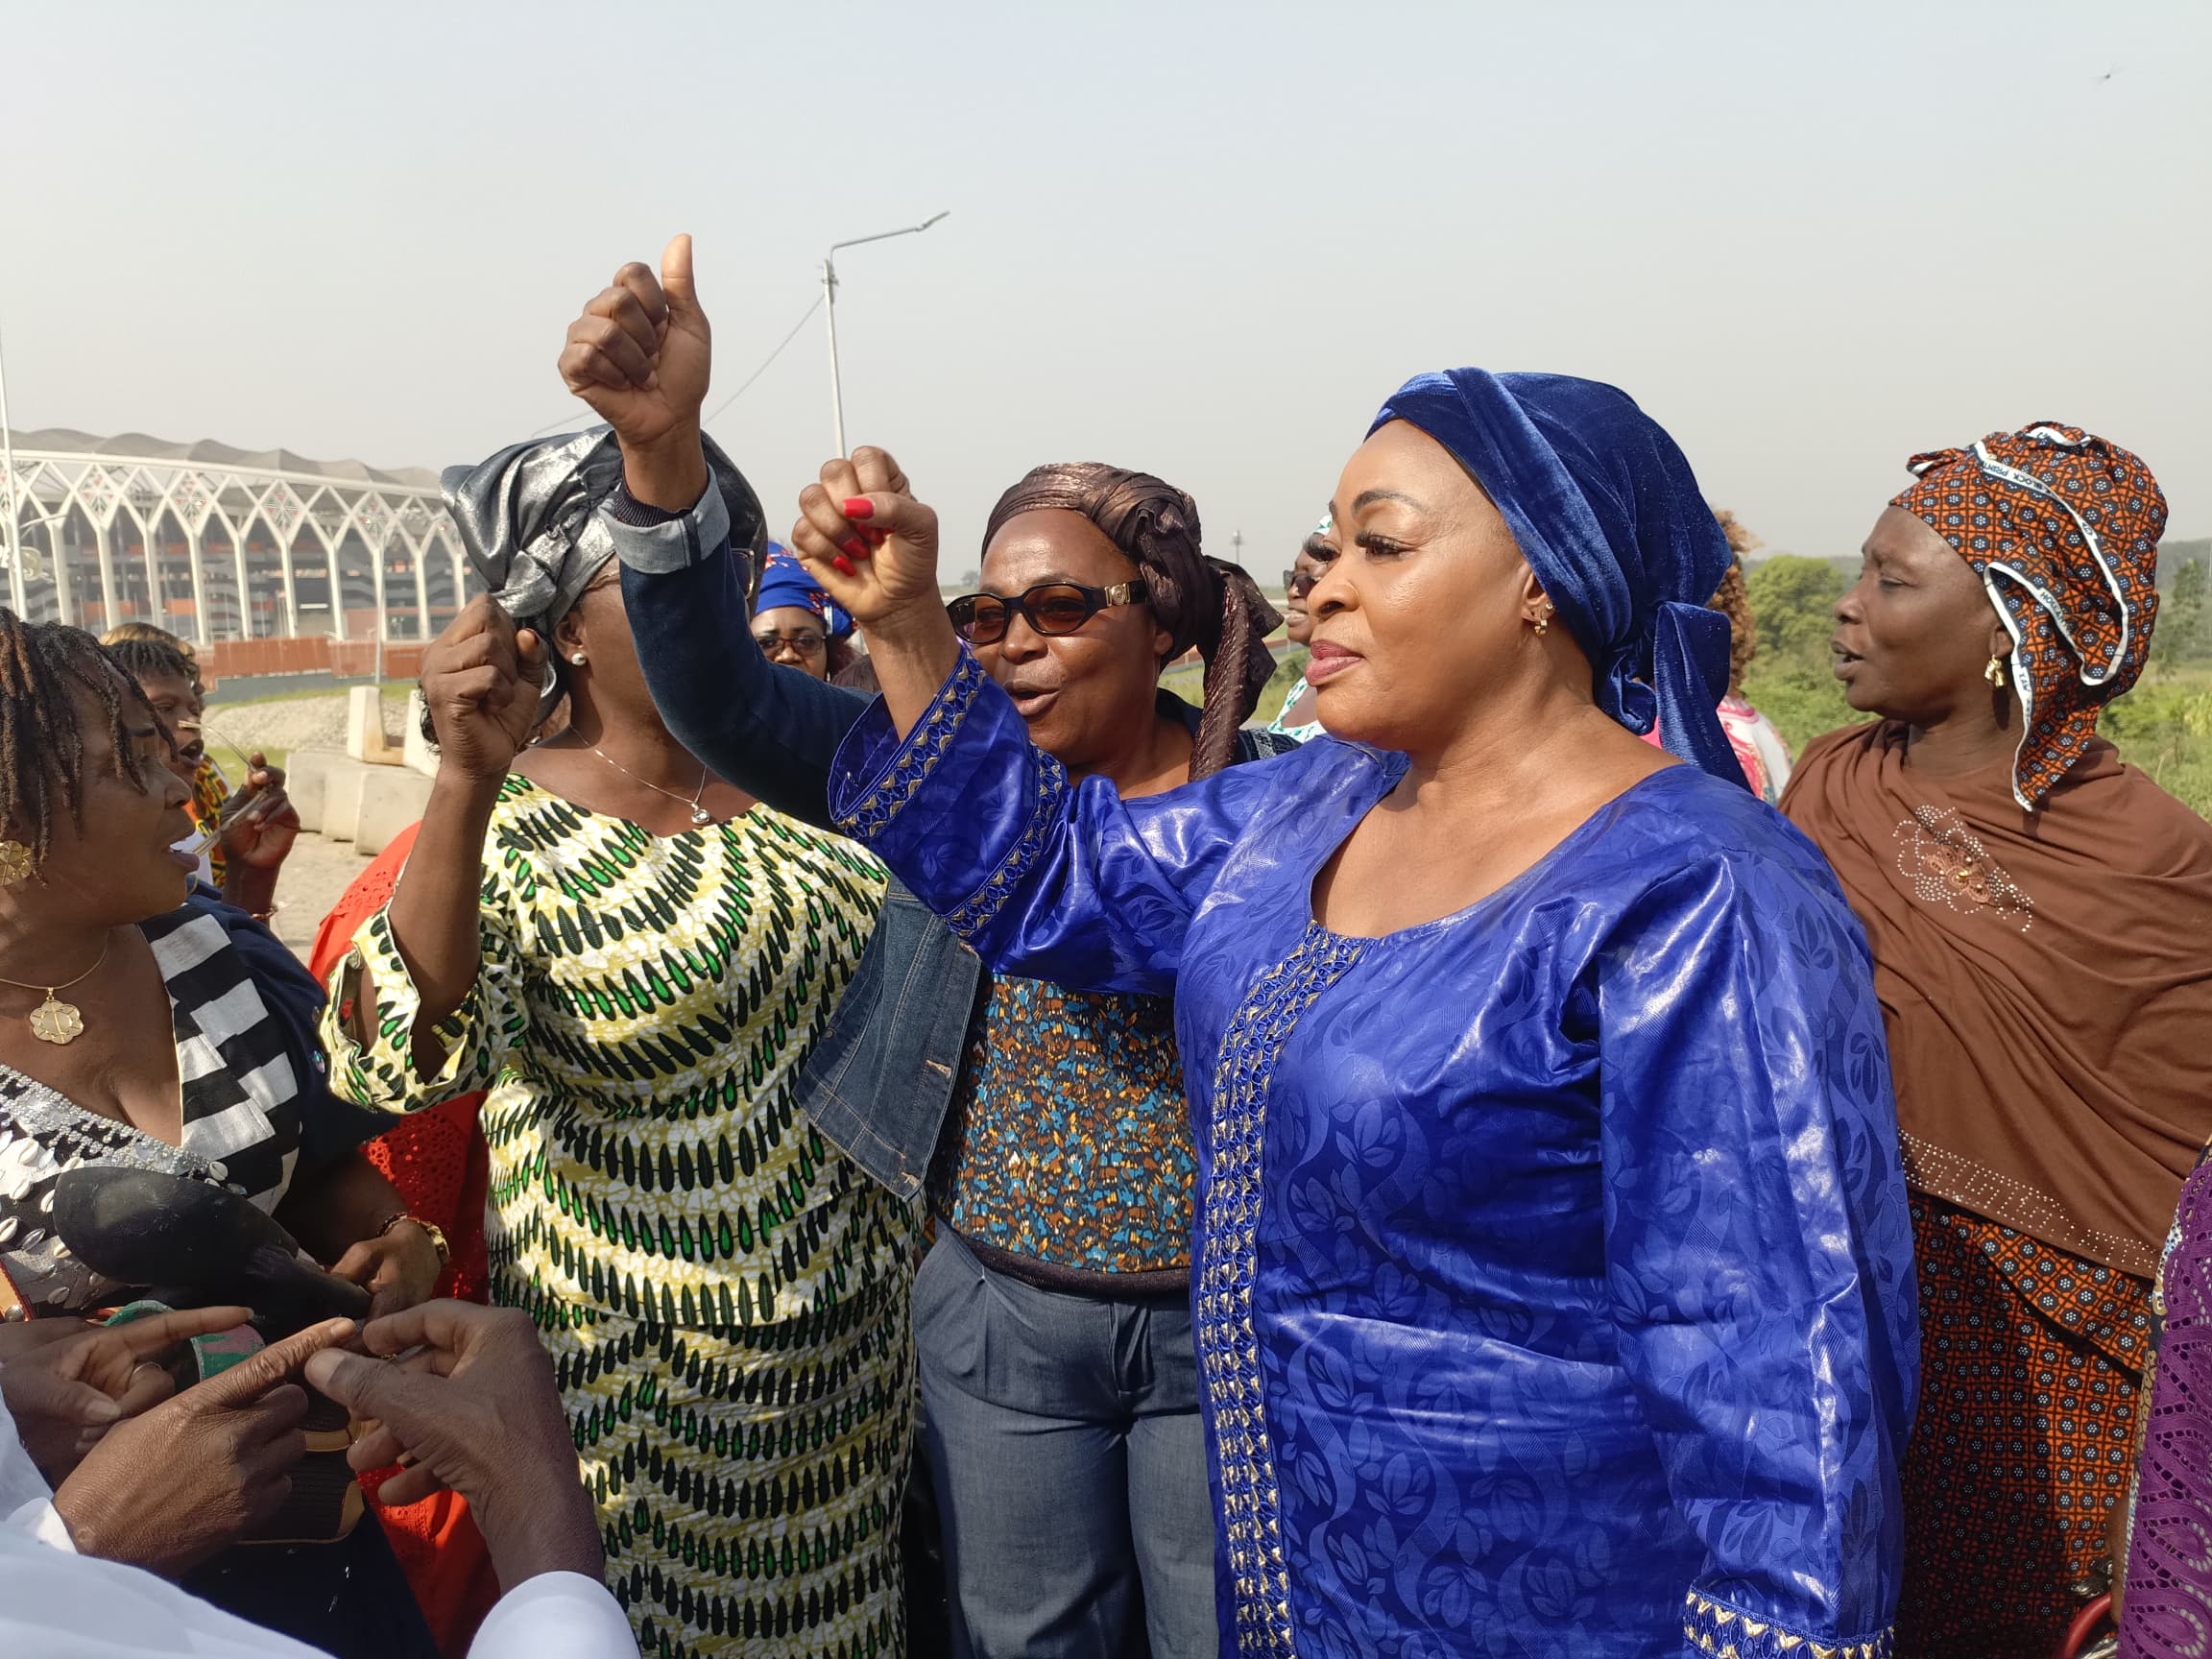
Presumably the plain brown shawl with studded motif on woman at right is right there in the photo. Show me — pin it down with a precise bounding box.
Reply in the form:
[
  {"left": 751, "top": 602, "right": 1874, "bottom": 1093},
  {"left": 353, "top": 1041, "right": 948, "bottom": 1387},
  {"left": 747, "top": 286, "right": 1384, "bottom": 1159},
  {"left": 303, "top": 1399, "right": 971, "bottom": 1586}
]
[{"left": 1781, "top": 723, "right": 2212, "bottom": 1279}]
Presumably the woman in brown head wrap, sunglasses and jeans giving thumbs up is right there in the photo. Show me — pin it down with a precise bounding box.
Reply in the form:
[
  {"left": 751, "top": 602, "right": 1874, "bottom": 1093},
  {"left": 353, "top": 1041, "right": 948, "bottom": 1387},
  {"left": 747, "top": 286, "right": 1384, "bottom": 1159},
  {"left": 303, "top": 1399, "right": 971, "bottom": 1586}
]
[{"left": 562, "top": 239, "right": 1287, "bottom": 1659}]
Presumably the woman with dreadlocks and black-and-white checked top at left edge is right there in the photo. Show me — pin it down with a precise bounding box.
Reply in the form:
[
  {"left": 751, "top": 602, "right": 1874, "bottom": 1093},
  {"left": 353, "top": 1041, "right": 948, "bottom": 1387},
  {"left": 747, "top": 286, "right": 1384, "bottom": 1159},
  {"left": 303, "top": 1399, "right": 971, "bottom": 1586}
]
[{"left": 0, "top": 611, "right": 440, "bottom": 1657}]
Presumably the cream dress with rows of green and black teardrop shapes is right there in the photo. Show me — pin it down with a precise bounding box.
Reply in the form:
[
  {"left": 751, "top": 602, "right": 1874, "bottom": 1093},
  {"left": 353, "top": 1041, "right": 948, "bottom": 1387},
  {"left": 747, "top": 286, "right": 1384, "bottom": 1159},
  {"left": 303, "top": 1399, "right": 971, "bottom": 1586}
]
[{"left": 325, "top": 777, "right": 918, "bottom": 1659}]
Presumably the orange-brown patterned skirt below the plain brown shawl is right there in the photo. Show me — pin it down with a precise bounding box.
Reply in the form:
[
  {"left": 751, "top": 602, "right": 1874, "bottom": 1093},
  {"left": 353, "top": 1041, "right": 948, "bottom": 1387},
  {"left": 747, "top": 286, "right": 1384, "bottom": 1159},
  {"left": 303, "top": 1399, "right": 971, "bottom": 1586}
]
[{"left": 1898, "top": 1192, "right": 2150, "bottom": 1659}]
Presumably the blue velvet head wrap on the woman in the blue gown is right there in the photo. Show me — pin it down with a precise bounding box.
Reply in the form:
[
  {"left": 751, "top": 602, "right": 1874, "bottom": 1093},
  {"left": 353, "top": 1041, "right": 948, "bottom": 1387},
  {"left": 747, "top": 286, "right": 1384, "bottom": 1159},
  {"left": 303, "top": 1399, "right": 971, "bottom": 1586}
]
[{"left": 1367, "top": 370, "right": 1743, "bottom": 783}]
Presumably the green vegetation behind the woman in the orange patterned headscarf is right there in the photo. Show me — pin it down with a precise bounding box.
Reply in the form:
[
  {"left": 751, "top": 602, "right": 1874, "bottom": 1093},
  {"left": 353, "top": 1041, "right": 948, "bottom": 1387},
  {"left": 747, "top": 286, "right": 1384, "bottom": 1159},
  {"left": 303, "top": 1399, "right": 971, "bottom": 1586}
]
[{"left": 1743, "top": 553, "right": 2212, "bottom": 816}]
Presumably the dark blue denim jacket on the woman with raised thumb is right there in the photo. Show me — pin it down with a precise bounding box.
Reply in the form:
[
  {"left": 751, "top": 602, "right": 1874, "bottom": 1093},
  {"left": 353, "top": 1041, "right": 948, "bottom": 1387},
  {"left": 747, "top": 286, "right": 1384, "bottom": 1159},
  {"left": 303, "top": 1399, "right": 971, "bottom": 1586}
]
[{"left": 602, "top": 489, "right": 1292, "bottom": 1199}]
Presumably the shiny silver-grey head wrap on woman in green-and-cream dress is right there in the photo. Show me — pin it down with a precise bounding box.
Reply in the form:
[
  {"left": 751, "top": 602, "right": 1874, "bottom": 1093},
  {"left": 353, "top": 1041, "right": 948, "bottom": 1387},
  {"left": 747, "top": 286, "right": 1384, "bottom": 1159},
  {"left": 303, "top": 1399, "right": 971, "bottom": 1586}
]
[{"left": 438, "top": 424, "right": 767, "bottom": 714}]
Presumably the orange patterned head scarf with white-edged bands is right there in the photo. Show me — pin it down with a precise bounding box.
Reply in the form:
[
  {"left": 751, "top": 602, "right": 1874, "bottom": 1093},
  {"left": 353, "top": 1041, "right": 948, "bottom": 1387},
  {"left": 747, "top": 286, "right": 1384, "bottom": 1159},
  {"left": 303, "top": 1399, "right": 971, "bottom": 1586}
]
[{"left": 1889, "top": 421, "right": 2166, "bottom": 812}]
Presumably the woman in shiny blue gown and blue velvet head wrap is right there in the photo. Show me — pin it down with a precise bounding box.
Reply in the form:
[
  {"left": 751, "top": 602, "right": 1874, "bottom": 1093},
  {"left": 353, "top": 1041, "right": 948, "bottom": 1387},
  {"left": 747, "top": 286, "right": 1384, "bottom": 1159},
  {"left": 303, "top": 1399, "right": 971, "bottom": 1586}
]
[{"left": 631, "top": 351, "right": 1918, "bottom": 1659}]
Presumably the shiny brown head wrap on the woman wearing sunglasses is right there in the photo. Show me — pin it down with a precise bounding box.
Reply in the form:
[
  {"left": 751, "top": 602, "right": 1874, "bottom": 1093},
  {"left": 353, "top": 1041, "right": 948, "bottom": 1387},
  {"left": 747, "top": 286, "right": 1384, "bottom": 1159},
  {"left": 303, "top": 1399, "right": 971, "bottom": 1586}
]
[{"left": 982, "top": 460, "right": 1281, "bottom": 779}]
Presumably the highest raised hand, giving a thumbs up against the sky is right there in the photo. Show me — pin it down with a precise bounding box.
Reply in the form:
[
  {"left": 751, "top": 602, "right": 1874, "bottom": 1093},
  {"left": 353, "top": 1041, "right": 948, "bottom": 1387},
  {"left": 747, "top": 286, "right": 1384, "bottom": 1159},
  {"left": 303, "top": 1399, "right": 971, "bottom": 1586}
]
[{"left": 560, "top": 237, "right": 714, "bottom": 457}]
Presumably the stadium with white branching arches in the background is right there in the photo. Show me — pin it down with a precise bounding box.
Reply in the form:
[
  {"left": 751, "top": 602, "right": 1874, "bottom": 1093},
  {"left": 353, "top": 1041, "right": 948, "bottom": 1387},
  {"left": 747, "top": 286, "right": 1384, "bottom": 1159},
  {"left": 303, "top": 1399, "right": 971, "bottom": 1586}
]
[{"left": 0, "top": 429, "right": 469, "bottom": 675}]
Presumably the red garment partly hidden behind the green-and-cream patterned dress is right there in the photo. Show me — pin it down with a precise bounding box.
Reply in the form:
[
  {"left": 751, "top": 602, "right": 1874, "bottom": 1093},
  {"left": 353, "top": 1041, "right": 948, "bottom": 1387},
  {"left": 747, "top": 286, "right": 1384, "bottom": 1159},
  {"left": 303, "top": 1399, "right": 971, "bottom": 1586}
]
[{"left": 307, "top": 825, "right": 500, "bottom": 1659}]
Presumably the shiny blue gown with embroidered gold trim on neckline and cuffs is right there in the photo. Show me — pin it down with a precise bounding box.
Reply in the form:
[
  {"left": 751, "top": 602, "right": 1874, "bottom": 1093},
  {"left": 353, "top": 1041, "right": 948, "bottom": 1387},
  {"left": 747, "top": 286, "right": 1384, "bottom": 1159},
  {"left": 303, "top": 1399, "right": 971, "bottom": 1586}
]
[{"left": 836, "top": 655, "right": 1918, "bottom": 1659}]
